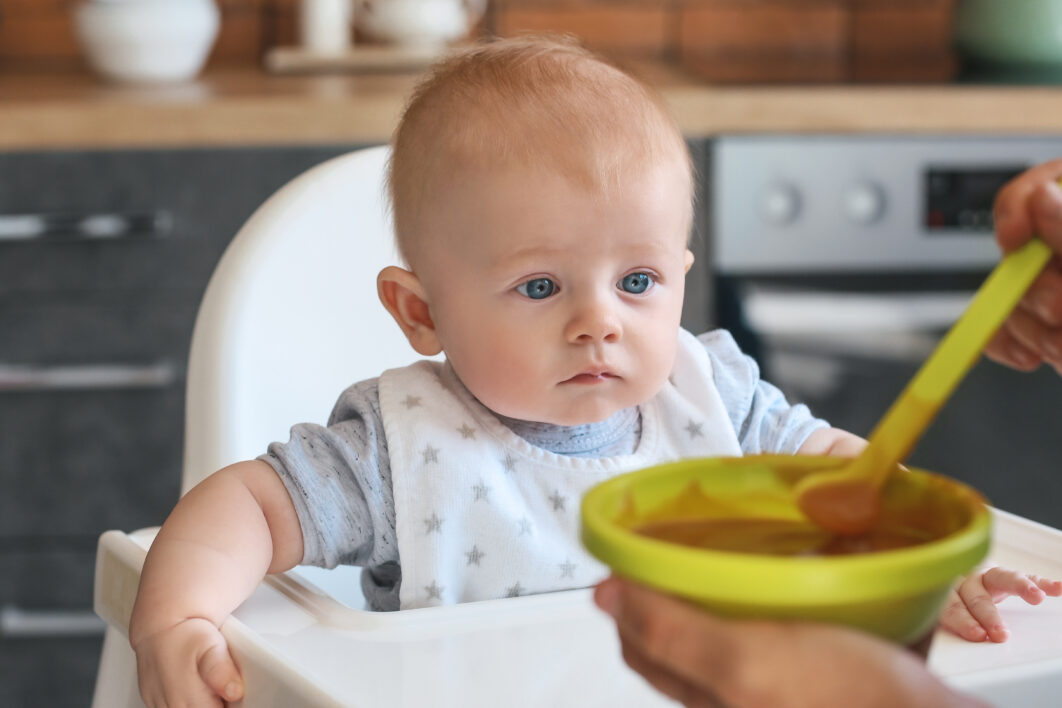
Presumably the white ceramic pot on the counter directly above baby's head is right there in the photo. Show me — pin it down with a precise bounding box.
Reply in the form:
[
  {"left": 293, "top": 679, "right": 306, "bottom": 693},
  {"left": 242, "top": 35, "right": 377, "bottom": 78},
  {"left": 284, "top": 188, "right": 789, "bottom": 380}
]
[{"left": 355, "top": 0, "right": 486, "bottom": 47}]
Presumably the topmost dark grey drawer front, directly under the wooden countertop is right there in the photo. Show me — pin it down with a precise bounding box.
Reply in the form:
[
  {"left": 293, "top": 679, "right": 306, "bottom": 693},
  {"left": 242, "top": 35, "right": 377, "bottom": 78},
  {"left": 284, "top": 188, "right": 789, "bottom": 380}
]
[{"left": 0, "top": 146, "right": 350, "bottom": 296}]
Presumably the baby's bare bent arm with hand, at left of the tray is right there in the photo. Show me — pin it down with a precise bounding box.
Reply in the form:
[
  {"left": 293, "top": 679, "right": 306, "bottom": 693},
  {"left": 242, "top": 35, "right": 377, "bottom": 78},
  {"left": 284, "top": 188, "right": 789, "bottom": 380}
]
[{"left": 130, "top": 461, "right": 303, "bottom": 707}]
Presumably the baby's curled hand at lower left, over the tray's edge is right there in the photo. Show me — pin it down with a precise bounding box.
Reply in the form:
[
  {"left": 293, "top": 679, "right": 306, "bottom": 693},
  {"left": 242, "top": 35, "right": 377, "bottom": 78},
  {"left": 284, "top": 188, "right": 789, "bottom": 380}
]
[{"left": 134, "top": 618, "right": 243, "bottom": 708}]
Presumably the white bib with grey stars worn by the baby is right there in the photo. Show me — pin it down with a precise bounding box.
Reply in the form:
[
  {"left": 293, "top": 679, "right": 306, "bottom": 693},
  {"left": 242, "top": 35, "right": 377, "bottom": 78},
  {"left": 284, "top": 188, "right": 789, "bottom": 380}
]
[{"left": 379, "top": 330, "right": 741, "bottom": 609}]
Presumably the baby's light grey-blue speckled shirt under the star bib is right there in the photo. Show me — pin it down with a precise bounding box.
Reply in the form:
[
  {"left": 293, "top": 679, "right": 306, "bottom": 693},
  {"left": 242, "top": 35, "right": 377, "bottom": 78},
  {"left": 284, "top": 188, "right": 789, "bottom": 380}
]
[{"left": 259, "top": 330, "right": 826, "bottom": 610}]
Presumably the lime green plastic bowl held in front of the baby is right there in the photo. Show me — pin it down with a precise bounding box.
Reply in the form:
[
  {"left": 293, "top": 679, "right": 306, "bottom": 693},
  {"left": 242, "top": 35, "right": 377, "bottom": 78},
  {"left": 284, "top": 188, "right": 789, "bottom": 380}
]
[{"left": 582, "top": 455, "right": 991, "bottom": 644}]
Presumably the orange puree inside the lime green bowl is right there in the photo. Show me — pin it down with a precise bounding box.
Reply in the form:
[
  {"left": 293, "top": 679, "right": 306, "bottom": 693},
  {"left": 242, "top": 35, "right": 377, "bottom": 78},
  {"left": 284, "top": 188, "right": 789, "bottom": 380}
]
[{"left": 633, "top": 518, "right": 936, "bottom": 555}]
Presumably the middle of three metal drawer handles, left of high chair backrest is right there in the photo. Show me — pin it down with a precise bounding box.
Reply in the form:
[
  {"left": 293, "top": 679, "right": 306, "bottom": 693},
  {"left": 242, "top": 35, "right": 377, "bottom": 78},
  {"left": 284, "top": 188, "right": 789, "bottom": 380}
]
[{"left": 0, "top": 361, "right": 177, "bottom": 392}]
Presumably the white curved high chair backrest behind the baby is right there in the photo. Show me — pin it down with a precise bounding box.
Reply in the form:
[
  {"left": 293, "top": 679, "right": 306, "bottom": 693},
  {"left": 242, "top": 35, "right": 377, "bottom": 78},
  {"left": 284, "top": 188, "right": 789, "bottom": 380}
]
[{"left": 182, "top": 146, "right": 417, "bottom": 494}]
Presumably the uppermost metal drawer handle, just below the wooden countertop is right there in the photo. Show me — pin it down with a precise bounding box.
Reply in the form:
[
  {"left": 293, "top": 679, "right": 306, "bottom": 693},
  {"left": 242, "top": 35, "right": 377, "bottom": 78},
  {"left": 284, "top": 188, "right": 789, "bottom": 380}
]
[{"left": 0, "top": 210, "right": 173, "bottom": 241}]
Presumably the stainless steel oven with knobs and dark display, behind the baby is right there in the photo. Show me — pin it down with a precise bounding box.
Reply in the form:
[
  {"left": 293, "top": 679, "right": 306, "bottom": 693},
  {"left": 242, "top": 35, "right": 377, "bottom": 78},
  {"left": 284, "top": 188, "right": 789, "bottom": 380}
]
[{"left": 708, "top": 136, "right": 1062, "bottom": 526}]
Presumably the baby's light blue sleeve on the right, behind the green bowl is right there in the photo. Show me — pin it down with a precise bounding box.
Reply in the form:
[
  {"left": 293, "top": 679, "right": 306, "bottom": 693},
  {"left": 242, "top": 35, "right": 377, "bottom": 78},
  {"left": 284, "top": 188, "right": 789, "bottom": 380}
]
[{"left": 697, "top": 329, "right": 829, "bottom": 454}]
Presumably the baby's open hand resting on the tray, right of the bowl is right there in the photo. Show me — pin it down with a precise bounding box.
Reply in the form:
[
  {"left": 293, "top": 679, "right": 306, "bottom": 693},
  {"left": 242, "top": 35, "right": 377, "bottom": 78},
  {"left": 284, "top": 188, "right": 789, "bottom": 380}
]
[{"left": 940, "top": 568, "right": 1062, "bottom": 641}]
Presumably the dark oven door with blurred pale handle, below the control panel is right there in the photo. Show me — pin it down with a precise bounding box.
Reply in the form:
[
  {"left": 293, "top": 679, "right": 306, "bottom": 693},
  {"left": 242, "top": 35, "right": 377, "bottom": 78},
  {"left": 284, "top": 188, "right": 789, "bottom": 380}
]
[{"left": 717, "top": 278, "right": 1062, "bottom": 528}]
